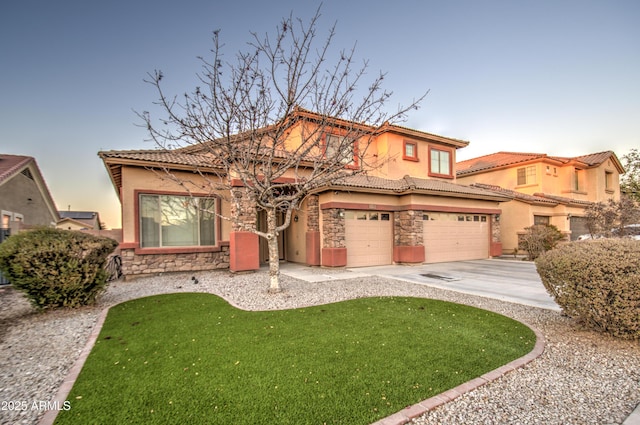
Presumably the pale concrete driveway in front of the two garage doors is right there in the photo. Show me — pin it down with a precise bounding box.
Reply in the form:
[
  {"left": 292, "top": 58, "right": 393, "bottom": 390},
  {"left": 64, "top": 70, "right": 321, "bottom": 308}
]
[{"left": 282, "top": 259, "right": 560, "bottom": 311}]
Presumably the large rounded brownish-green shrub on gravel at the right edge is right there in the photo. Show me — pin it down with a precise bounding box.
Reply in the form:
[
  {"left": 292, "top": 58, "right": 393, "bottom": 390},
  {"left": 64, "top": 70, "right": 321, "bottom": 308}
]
[{"left": 536, "top": 239, "right": 640, "bottom": 339}]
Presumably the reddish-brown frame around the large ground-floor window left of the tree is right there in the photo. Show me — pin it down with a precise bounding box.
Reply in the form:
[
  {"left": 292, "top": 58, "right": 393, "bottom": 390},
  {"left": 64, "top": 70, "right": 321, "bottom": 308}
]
[{"left": 134, "top": 190, "right": 223, "bottom": 254}]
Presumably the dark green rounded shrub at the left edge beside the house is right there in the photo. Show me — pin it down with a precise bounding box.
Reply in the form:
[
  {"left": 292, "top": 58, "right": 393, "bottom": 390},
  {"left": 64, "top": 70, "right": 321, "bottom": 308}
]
[{"left": 0, "top": 228, "right": 118, "bottom": 309}]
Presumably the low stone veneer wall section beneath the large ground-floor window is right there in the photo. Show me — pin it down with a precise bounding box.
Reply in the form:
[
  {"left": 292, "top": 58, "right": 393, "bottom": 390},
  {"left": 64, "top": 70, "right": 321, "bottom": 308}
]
[{"left": 121, "top": 246, "right": 229, "bottom": 277}]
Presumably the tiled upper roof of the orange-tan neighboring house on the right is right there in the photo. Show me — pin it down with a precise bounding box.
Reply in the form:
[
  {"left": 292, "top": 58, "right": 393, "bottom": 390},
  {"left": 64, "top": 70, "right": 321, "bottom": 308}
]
[{"left": 456, "top": 151, "right": 624, "bottom": 176}]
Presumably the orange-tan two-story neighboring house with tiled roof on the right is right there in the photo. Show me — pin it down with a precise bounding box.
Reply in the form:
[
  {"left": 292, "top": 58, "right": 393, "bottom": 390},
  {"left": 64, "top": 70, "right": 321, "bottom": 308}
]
[{"left": 457, "top": 151, "right": 624, "bottom": 252}]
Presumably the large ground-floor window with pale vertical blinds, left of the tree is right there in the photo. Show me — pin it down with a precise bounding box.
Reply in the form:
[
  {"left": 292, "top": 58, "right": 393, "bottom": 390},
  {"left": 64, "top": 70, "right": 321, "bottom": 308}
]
[{"left": 140, "top": 195, "right": 216, "bottom": 248}]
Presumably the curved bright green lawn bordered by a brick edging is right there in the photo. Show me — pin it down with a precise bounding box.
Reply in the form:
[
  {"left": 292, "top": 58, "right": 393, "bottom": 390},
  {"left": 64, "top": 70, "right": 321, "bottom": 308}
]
[{"left": 56, "top": 294, "right": 535, "bottom": 425}]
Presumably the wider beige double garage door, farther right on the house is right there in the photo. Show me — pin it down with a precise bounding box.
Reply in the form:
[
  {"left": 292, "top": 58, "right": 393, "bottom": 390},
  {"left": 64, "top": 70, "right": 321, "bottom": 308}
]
[{"left": 423, "top": 213, "right": 489, "bottom": 263}]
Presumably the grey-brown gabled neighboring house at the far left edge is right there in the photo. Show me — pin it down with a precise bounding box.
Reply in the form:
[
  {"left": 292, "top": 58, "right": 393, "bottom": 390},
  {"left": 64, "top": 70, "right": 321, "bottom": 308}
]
[{"left": 0, "top": 154, "right": 59, "bottom": 233}]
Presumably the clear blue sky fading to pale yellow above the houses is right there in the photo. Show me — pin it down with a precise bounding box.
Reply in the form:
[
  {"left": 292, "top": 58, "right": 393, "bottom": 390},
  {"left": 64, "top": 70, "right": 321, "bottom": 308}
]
[{"left": 0, "top": 0, "right": 640, "bottom": 228}]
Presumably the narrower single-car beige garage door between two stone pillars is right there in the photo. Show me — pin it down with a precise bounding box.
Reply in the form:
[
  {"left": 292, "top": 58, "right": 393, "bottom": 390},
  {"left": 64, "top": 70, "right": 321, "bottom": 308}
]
[{"left": 345, "top": 211, "right": 393, "bottom": 267}]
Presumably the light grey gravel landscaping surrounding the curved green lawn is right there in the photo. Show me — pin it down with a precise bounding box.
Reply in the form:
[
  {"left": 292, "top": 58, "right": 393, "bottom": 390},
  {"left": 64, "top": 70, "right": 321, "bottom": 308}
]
[{"left": 0, "top": 269, "right": 640, "bottom": 425}]
